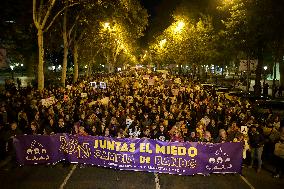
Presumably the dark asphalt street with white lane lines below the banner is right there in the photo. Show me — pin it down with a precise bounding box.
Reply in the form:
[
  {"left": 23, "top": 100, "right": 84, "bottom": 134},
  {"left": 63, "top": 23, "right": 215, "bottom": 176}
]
[{"left": 0, "top": 164, "right": 284, "bottom": 189}]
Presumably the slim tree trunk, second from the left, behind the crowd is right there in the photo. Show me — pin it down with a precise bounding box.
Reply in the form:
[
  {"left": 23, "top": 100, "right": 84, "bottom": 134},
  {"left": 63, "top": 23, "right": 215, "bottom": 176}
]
[{"left": 61, "top": 11, "right": 68, "bottom": 87}]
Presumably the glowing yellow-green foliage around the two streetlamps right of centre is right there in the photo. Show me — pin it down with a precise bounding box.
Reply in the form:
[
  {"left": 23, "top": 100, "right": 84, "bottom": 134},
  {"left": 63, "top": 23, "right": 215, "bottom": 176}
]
[{"left": 150, "top": 15, "right": 215, "bottom": 65}]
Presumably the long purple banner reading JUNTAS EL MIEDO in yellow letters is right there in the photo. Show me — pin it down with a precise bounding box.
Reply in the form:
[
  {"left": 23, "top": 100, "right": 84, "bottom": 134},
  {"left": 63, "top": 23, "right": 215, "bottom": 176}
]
[{"left": 14, "top": 134, "right": 242, "bottom": 175}]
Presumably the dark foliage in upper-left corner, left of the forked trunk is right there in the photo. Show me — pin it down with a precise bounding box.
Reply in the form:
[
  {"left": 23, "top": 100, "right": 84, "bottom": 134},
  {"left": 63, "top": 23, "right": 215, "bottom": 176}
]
[{"left": 0, "top": 0, "right": 36, "bottom": 75}]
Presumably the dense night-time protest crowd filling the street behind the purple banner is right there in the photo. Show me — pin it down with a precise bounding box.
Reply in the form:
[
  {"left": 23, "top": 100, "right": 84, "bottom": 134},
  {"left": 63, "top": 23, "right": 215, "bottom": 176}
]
[{"left": 0, "top": 71, "right": 284, "bottom": 176}]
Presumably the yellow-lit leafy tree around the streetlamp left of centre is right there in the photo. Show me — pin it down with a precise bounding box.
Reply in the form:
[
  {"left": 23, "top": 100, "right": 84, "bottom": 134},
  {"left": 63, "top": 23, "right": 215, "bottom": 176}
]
[{"left": 77, "top": 0, "right": 148, "bottom": 72}]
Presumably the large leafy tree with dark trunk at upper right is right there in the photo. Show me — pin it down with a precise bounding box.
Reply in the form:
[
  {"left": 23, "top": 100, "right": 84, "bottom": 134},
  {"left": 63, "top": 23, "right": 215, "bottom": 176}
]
[{"left": 220, "top": 0, "right": 271, "bottom": 94}]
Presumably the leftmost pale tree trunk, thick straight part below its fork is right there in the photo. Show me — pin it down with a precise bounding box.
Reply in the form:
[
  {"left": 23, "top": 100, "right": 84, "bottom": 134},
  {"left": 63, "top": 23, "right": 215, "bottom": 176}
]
[{"left": 37, "top": 28, "right": 44, "bottom": 90}]
